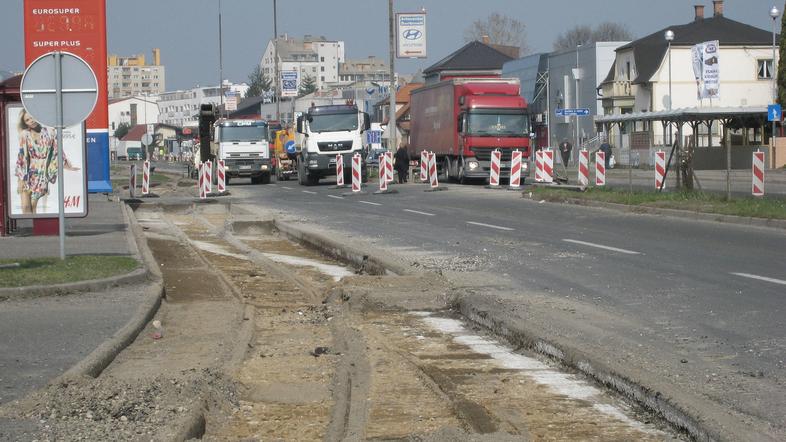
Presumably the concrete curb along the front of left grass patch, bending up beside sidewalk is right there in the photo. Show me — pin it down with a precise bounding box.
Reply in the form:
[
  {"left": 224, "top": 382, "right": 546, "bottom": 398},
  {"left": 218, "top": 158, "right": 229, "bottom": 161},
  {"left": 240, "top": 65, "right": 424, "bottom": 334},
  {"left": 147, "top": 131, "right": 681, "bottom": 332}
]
[{"left": 0, "top": 200, "right": 152, "bottom": 299}]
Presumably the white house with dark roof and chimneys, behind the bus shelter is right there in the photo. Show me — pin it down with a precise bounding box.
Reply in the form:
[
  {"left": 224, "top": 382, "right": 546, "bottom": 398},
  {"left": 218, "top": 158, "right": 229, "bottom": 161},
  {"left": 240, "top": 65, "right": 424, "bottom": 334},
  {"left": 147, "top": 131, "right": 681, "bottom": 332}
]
[{"left": 601, "top": 0, "right": 777, "bottom": 148}]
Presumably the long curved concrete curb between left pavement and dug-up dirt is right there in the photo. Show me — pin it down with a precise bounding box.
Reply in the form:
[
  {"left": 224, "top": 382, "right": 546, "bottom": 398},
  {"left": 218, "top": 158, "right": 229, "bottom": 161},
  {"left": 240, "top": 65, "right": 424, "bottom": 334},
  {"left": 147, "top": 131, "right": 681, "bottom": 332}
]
[{"left": 57, "top": 205, "right": 164, "bottom": 383}]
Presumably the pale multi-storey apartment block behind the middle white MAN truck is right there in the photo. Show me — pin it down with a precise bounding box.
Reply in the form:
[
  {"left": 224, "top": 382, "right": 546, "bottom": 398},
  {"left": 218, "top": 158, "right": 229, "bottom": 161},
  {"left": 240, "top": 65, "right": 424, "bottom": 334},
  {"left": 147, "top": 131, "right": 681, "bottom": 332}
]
[{"left": 259, "top": 35, "right": 344, "bottom": 90}]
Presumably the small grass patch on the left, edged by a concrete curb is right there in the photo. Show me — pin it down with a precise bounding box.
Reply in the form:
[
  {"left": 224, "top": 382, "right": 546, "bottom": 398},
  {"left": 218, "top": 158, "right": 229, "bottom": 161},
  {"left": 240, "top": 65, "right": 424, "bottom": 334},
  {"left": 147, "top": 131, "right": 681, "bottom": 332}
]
[{"left": 0, "top": 255, "right": 139, "bottom": 287}]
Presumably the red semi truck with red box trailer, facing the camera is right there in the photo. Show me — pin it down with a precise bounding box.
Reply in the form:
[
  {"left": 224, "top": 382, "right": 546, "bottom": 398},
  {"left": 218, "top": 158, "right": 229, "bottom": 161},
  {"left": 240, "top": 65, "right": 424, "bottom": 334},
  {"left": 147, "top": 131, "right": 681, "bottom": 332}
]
[{"left": 408, "top": 78, "right": 531, "bottom": 183}]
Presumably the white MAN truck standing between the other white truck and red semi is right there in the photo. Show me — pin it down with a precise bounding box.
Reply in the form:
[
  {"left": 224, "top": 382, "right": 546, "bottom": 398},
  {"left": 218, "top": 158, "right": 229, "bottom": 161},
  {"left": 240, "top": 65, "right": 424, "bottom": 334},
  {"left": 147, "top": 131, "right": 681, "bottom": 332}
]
[{"left": 295, "top": 104, "right": 371, "bottom": 186}]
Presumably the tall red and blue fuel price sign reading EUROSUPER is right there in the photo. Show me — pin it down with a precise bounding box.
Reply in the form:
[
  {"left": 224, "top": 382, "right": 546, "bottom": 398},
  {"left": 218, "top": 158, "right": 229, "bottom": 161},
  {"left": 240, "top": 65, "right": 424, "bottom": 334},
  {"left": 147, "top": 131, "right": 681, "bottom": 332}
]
[{"left": 24, "top": 0, "right": 112, "bottom": 192}]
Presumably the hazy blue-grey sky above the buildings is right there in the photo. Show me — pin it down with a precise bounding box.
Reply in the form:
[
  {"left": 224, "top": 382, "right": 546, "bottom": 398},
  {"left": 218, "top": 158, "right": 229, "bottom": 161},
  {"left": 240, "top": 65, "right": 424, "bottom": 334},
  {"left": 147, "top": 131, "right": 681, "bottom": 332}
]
[{"left": 0, "top": 0, "right": 784, "bottom": 91}]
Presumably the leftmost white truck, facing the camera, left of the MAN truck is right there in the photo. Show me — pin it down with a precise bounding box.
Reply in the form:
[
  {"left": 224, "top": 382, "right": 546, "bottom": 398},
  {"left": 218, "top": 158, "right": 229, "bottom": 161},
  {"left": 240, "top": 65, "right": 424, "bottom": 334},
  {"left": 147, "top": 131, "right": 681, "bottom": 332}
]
[{"left": 210, "top": 119, "right": 273, "bottom": 184}]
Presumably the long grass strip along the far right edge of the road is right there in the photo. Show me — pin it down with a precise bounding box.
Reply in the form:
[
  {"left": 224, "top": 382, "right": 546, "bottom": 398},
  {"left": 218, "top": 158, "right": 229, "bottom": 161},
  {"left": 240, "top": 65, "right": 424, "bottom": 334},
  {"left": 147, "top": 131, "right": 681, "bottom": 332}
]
[{"left": 532, "top": 187, "right": 786, "bottom": 219}]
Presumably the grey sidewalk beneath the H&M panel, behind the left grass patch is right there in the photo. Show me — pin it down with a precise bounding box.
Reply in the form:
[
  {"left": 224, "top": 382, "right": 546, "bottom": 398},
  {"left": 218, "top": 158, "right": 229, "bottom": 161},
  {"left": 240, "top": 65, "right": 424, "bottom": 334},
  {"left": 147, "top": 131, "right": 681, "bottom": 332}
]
[{"left": 0, "top": 194, "right": 134, "bottom": 259}]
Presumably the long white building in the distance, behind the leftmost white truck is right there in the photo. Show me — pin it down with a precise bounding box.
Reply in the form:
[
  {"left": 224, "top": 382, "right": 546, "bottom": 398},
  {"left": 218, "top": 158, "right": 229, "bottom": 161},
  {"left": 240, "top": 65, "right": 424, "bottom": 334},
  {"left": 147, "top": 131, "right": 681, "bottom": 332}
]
[{"left": 158, "top": 80, "right": 248, "bottom": 127}]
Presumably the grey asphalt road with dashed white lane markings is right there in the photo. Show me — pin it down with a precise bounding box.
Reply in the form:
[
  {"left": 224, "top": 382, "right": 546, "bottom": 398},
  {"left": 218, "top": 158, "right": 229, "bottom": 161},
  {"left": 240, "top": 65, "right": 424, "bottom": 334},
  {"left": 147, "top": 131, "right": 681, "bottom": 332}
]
[{"left": 230, "top": 178, "right": 786, "bottom": 436}]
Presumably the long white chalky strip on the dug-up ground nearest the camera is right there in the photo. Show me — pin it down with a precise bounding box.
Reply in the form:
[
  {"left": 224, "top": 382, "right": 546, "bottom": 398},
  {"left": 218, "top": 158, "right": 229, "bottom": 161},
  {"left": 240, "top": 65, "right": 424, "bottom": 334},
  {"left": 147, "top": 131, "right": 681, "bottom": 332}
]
[{"left": 414, "top": 312, "right": 652, "bottom": 432}]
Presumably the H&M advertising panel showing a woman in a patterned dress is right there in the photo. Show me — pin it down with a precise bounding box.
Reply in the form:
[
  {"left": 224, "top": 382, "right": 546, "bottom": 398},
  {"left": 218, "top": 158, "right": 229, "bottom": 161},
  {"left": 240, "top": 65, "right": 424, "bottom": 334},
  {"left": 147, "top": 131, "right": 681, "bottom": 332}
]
[{"left": 3, "top": 104, "right": 87, "bottom": 218}]
